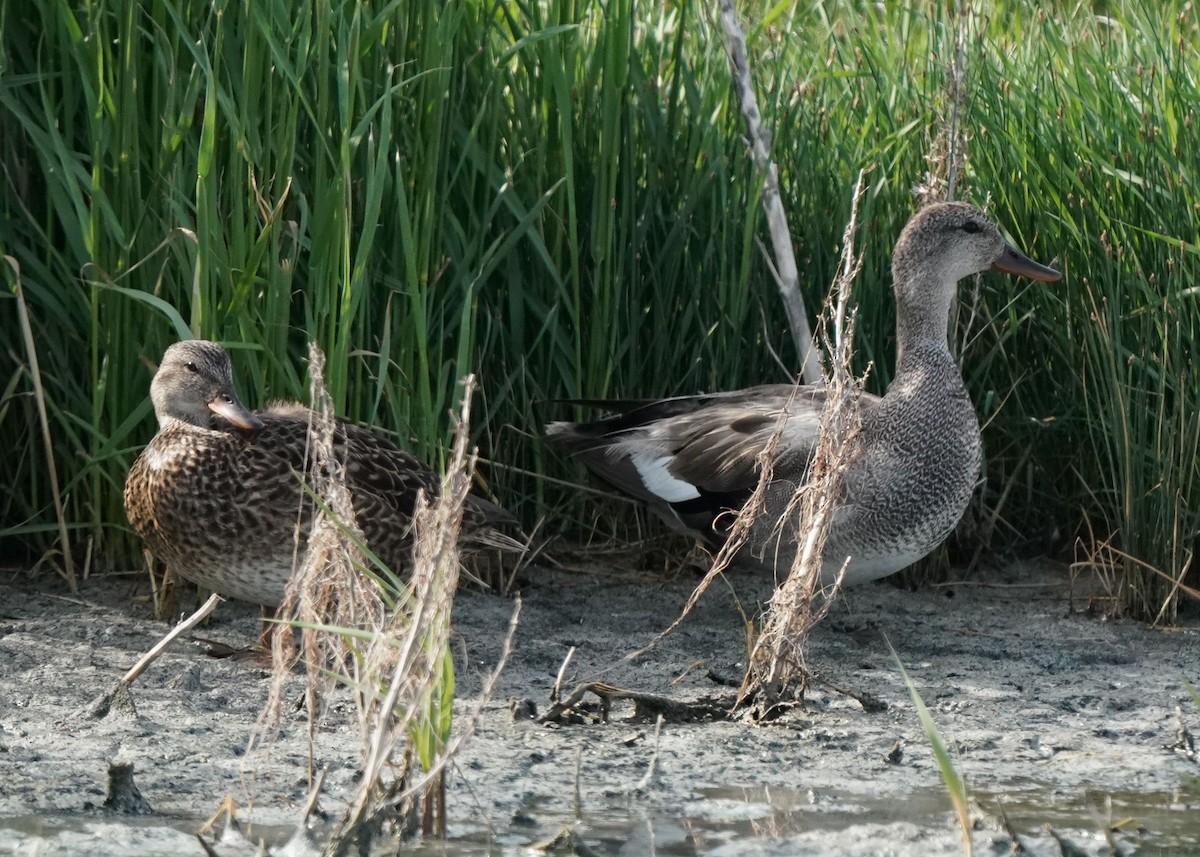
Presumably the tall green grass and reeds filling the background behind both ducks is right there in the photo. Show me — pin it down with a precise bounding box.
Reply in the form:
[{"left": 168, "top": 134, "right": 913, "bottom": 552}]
[{"left": 0, "top": 0, "right": 1200, "bottom": 615}]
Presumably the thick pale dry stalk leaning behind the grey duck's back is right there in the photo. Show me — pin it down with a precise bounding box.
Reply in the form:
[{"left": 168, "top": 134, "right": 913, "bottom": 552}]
[{"left": 718, "top": 0, "right": 821, "bottom": 384}]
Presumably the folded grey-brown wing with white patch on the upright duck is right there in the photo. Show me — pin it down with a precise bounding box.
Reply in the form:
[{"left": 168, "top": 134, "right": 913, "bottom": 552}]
[{"left": 546, "top": 384, "right": 859, "bottom": 535}]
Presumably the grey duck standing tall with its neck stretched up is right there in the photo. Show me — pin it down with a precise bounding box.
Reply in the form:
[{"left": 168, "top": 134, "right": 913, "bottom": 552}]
[{"left": 546, "top": 203, "right": 1061, "bottom": 585}]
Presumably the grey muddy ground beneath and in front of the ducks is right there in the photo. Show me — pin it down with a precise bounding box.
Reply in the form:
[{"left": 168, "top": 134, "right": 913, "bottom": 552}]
[{"left": 0, "top": 563, "right": 1200, "bottom": 857}]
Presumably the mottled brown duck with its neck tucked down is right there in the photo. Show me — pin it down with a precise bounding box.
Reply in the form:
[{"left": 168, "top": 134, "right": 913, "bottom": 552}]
[{"left": 125, "top": 340, "right": 517, "bottom": 607}]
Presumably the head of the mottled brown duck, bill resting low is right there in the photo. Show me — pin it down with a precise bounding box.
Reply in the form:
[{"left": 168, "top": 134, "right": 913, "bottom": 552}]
[{"left": 150, "top": 340, "right": 263, "bottom": 429}]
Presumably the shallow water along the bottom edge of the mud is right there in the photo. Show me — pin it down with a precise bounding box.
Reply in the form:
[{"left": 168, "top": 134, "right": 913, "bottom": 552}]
[{"left": 0, "top": 780, "right": 1200, "bottom": 857}]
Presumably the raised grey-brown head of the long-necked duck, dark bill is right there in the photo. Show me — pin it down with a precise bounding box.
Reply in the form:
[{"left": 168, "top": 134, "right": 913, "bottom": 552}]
[{"left": 892, "top": 203, "right": 1062, "bottom": 337}]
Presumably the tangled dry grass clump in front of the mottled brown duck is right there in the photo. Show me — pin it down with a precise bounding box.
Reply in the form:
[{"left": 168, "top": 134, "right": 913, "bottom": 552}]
[{"left": 243, "top": 344, "right": 521, "bottom": 855}]
